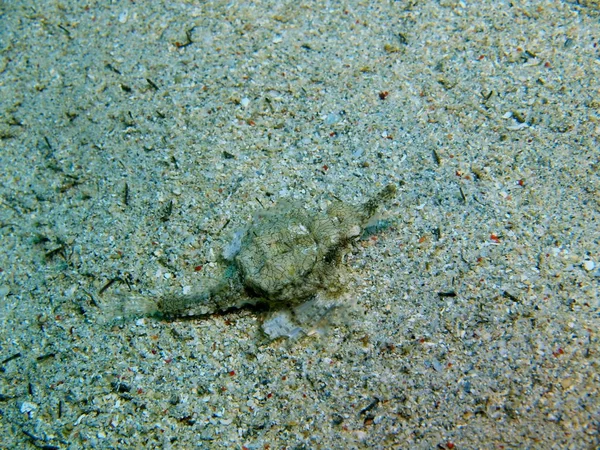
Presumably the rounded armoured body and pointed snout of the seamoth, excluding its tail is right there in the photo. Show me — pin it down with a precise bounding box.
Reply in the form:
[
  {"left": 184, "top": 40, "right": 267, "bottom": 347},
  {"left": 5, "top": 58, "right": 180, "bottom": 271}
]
[{"left": 235, "top": 185, "right": 396, "bottom": 302}]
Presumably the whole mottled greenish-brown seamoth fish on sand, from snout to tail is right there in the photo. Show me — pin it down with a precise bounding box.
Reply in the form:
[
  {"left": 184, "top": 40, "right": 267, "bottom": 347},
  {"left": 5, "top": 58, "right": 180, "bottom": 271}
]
[{"left": 157, "top": 185, "right": 396, "bottom": 317}]
